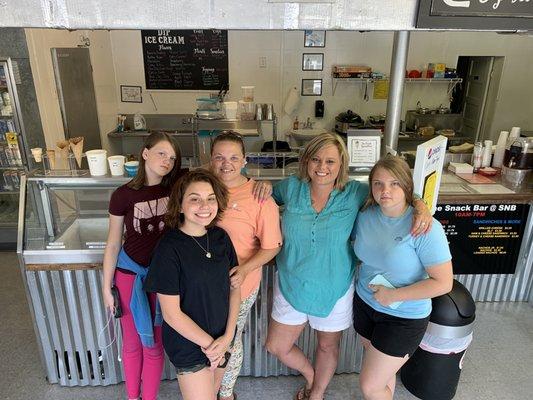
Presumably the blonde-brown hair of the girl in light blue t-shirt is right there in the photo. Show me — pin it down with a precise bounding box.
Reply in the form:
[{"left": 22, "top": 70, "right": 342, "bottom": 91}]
[{"left": 361, "top": 154, "right": 414, "bottom": 211}]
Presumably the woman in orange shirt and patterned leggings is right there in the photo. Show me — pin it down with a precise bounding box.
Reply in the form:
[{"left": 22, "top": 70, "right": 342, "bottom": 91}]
[{"left": 210, "top": 131, "right": 282, "bottom": 400}]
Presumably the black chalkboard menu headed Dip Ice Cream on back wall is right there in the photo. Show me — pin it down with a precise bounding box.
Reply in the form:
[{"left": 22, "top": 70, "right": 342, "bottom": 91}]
[{"left": 141, "top": 29, "right": 229, "bottom": 90}]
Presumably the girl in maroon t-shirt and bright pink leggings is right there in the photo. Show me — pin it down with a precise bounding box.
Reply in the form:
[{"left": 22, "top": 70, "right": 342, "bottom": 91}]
[{"left": 102, "top": 132, "right": 181, "bottom": 400}]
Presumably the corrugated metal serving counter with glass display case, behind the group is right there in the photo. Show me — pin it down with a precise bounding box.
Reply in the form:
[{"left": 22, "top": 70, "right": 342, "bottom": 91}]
[{"left": 18, "top": 171, "right": 533, "bottom": 386}]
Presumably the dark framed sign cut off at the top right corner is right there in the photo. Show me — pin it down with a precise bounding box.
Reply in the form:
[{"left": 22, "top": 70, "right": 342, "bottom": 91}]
[{"left": 416, "top": 0, "right": 533, "bottom": 31}]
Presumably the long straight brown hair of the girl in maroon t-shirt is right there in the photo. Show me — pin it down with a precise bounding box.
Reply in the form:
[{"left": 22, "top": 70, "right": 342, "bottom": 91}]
[{"left": 128, "top": 132, "right": 181, "bottom": 190}]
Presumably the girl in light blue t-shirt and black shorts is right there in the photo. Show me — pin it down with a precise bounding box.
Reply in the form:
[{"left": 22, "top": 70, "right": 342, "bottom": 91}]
[{"left": 353, "top": 156, "right": 453, "bottom": 399}]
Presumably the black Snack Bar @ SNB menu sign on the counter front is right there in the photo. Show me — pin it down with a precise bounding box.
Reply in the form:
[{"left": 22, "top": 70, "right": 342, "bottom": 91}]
[{"left": 434, "top": 204, "right": 530, "bottom": 274}]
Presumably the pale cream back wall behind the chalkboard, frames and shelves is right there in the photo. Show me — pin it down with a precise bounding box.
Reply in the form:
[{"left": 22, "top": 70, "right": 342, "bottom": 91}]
[{"left": 111, "top": 31, "right": 533, "bottom": 141}]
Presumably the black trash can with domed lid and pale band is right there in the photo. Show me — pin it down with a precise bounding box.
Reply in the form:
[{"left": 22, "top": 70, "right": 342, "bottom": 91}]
[{"left": 400, "top": 280, "right": 476, "bottom": 400}]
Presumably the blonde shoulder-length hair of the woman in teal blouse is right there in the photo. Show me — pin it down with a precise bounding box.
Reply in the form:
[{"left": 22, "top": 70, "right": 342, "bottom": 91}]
[{"left": 298, "top": 132, "right": 348, "bottom": 190}]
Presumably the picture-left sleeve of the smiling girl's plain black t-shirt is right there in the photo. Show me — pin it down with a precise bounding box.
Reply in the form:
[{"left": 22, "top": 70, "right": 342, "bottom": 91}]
[{"left": 144, "top": 232, "right": 181, "bottom": 295}]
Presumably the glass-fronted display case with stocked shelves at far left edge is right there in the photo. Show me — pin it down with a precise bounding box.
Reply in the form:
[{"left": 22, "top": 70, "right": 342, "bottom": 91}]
[{"left": 0, "top": 58, "right": 28, "bottom": 250}]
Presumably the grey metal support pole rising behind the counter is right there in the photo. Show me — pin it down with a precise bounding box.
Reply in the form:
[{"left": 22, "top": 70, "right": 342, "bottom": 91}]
[{"left": 381, "top": 31, "right": 409, "bottom": 154}]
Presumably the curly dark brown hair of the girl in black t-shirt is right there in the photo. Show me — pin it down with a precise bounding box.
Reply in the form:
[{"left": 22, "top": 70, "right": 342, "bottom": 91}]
[{"left": 165, "top": 168, "right": 228, "bottom": 228}]
